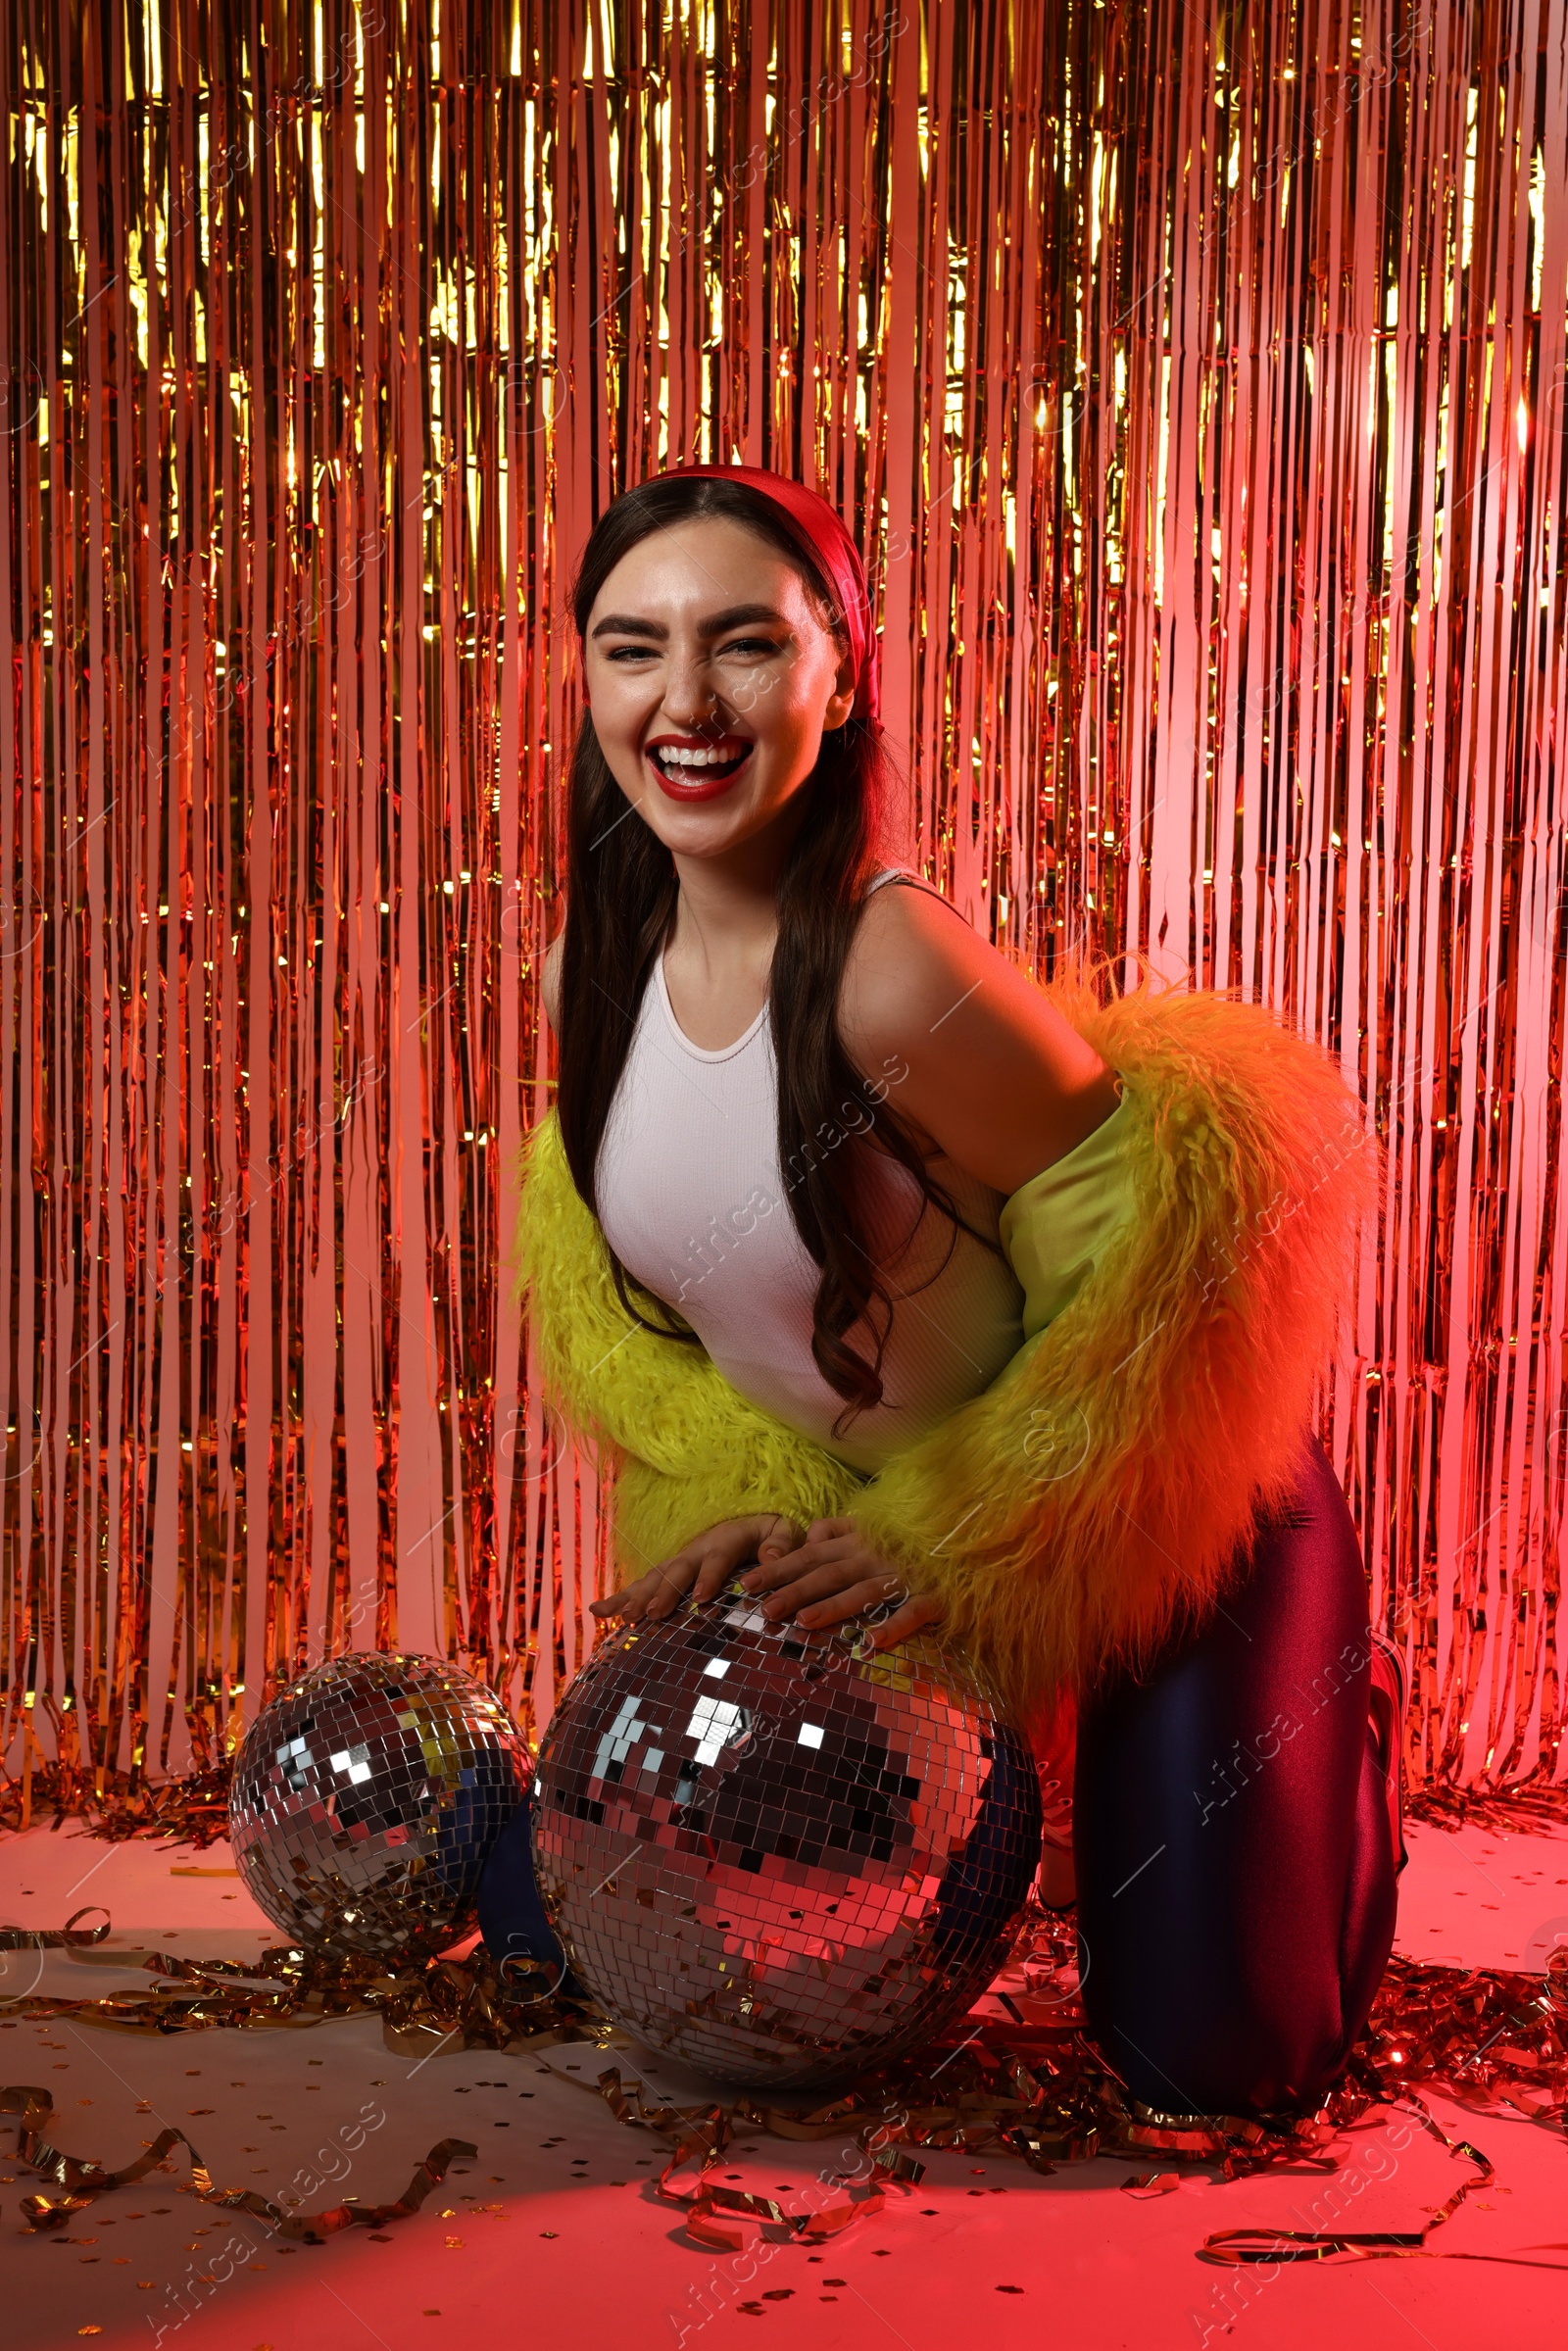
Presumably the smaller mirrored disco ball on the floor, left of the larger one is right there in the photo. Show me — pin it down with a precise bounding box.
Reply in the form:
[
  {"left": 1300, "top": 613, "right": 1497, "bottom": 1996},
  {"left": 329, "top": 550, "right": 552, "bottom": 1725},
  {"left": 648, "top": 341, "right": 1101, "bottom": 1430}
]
[{"left": 228, "top": 1655, "right": 531, "bottom": 1963}]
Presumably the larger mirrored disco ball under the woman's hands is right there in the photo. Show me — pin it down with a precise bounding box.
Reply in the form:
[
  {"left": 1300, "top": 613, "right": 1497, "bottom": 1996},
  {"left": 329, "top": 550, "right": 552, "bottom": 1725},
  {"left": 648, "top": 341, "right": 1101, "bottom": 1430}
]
[{"left": 534, "top": 1587, "right": 1039, "bottom": 2085}]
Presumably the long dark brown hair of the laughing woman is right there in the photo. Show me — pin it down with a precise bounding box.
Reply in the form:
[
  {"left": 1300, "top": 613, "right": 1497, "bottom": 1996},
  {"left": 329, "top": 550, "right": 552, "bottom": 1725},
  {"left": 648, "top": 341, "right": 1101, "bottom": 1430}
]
[{"left": 558, "top": 475, "right": 985, "bottom": 1434}]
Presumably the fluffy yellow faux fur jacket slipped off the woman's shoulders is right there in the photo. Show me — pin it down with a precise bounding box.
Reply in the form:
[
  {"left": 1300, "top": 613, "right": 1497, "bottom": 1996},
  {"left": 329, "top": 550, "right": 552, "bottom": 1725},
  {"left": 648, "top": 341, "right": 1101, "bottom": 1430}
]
[{"left": 517, "top": 976, "right": 1378, "bottom": 1716}]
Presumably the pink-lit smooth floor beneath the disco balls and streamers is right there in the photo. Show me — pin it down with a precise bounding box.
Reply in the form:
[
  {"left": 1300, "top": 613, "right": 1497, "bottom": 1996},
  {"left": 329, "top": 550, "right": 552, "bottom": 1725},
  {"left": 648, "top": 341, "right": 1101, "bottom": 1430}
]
[{"left": 0, "top": 1827, "right": 1568, "bottom": 2351}]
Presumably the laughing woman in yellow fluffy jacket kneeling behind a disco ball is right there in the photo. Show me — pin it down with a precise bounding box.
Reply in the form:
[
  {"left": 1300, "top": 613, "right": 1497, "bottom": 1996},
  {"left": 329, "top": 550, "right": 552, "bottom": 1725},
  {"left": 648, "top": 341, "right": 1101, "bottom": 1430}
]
[{"left": 487, "top": 465, "right": 1401, "bottom": 2114}]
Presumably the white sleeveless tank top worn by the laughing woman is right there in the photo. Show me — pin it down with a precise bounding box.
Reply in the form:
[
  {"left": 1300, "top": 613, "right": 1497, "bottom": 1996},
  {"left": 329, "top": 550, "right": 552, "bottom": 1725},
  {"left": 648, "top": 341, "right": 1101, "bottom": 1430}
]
[{"left": 597, "top": 870, "right": 1022, "bottom": 1472}]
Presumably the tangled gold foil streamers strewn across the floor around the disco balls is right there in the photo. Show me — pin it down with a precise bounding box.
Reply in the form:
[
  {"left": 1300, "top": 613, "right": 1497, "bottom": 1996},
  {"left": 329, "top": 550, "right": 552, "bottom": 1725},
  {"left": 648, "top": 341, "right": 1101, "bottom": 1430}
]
[{"left": 0, "top": 1907, "right": 1568, "bottom": 2267}]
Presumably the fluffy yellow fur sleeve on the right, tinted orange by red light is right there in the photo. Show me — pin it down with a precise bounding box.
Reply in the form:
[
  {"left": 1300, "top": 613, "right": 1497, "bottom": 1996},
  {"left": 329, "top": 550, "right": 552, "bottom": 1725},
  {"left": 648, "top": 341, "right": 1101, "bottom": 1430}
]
[{"left": 856, "top": 963, "right": 1378, "bottom": 1707}]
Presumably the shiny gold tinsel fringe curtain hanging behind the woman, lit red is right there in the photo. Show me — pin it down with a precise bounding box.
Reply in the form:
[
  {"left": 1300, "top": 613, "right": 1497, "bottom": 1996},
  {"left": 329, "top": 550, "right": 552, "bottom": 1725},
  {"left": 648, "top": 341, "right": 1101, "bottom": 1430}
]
[{"left": 0, "top": 0, "right": 1568, "bottom": 1817}]
